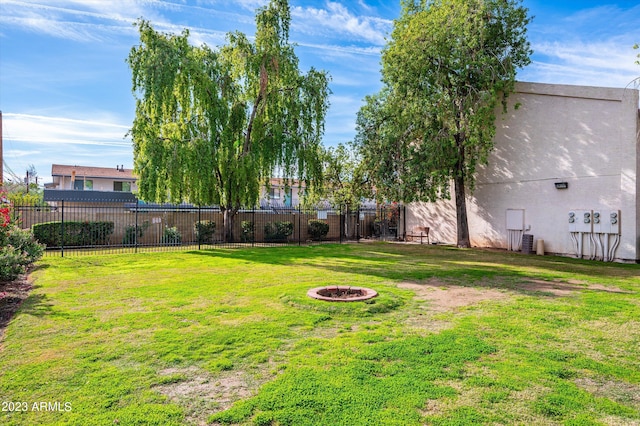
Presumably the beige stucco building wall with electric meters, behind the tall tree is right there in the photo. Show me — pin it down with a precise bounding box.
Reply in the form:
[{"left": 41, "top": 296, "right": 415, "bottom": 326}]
[{"left": 406, "top": 83, "right": 640, "bottom": 261}]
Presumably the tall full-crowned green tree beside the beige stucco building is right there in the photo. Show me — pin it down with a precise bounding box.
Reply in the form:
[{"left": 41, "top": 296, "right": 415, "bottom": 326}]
[{"left": 356, "top": 0, "right": 531, "bottom": 247}]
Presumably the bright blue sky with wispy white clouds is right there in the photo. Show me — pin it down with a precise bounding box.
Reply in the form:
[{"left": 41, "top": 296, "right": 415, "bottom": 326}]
[{"left": 0, "top": 0, "right": 640, "bottom": 181}]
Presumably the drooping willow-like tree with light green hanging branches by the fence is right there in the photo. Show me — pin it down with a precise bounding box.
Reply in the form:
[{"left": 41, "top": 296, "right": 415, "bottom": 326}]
[{"left": 128, "top": 0, "right": 329, "bottom": 241}]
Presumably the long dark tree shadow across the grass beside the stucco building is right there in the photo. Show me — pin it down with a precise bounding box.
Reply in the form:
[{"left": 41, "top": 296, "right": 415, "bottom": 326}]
[{"left": 189, "top": 243, "right": 640, "bottom": 296}]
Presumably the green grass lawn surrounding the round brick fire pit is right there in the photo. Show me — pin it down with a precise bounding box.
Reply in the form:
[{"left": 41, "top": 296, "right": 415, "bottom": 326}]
[{"left": 0, "top": 243, "right": 640, "bottom": 426}]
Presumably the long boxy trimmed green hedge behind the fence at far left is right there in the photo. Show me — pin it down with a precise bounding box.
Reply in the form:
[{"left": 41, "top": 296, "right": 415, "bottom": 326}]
[{"left": 32, "top": 221, "right": 114, "bottom": 247}]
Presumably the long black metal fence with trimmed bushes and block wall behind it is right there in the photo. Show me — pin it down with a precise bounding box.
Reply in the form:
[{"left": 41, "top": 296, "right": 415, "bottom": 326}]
[{"left": 13, "top": 201, "right": 403, "bottom": 256}]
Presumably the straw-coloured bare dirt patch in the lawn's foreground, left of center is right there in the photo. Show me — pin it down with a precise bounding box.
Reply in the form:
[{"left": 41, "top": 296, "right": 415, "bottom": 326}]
[{"left": 154, "top": 367, "right": 259, "bottom": 426}]
